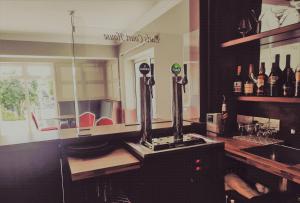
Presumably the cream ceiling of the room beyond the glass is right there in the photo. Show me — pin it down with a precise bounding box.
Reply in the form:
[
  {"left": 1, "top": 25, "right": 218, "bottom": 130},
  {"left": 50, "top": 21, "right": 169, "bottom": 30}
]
[{"left": 0, "top": 0, "right": 181, "bottom": 44}]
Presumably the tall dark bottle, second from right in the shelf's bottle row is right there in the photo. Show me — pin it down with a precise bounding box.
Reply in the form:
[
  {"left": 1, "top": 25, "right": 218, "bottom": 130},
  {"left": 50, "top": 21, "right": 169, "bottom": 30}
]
[{"left": 282, "top": 54, "right": 295, "bottom": 97}]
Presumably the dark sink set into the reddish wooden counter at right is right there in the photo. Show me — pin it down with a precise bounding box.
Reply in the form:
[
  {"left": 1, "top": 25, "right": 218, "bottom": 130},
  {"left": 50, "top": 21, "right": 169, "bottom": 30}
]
[{"left": 243, "top": 144, "right": 300, "bottom": 165}]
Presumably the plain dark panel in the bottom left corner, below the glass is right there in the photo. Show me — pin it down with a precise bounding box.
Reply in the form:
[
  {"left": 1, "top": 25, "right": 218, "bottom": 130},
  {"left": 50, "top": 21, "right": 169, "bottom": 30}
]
[{"left": 0, "top": 142, "right": 62, "bottom": 203}]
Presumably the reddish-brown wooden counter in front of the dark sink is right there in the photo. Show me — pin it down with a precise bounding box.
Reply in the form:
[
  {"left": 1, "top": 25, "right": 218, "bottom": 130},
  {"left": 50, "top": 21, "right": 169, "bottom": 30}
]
[{"left": 209, "top": 136, "right": 300, "bottom": 184}]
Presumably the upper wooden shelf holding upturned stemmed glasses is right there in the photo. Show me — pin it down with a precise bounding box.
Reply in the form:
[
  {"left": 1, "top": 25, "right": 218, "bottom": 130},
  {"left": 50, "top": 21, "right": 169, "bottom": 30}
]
[{"left": 221, "top": 23, "right": 300, "bottom": 48}]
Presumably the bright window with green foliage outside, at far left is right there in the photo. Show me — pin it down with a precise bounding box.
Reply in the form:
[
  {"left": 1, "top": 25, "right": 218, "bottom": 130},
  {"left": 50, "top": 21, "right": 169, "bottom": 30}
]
[{"left": 0, "top": 63, "right": 57, "bottom": 136}]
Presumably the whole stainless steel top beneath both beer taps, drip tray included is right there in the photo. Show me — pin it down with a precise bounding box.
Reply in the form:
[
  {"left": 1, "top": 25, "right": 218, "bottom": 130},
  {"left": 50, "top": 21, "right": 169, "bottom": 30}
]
[{"left": 126, "top": 133, "right": 223, "bottom": 158}]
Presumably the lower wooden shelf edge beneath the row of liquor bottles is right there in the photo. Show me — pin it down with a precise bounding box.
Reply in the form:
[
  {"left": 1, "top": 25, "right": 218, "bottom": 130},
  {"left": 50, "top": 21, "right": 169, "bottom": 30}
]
[{"left": 237, "top": 96, "right": 300, "bottom": 104}]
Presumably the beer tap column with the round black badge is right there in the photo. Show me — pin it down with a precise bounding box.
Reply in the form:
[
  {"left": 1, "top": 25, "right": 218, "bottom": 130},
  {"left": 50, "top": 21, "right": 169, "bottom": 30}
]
[{"left": 139, "top": 63, "right": 155, "bottom": 145}]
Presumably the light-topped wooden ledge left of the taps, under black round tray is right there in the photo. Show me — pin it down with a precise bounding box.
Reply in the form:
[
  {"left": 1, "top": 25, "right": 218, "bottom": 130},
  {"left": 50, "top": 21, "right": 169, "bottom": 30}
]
[{"left": 67, "top": 148, "right": 140, "bottom": 181}]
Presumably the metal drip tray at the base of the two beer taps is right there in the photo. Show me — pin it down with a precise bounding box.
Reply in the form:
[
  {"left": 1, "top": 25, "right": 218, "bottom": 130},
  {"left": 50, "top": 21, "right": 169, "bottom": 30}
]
[{"left": 144, "top": 133, "right": 206, "bottom": 151}]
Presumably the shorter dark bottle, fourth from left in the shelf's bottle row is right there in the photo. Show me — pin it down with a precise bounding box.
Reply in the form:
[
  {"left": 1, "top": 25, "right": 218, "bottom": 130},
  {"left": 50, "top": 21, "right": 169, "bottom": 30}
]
[{"left": 269, "top": 63, "right": 281, "bottom": 97}]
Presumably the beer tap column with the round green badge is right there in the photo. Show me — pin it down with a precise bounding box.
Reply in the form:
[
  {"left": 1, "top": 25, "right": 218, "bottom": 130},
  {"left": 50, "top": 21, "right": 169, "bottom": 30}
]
[{"left": 171, "top": 63, "right": 188, "bottom": 143}]
